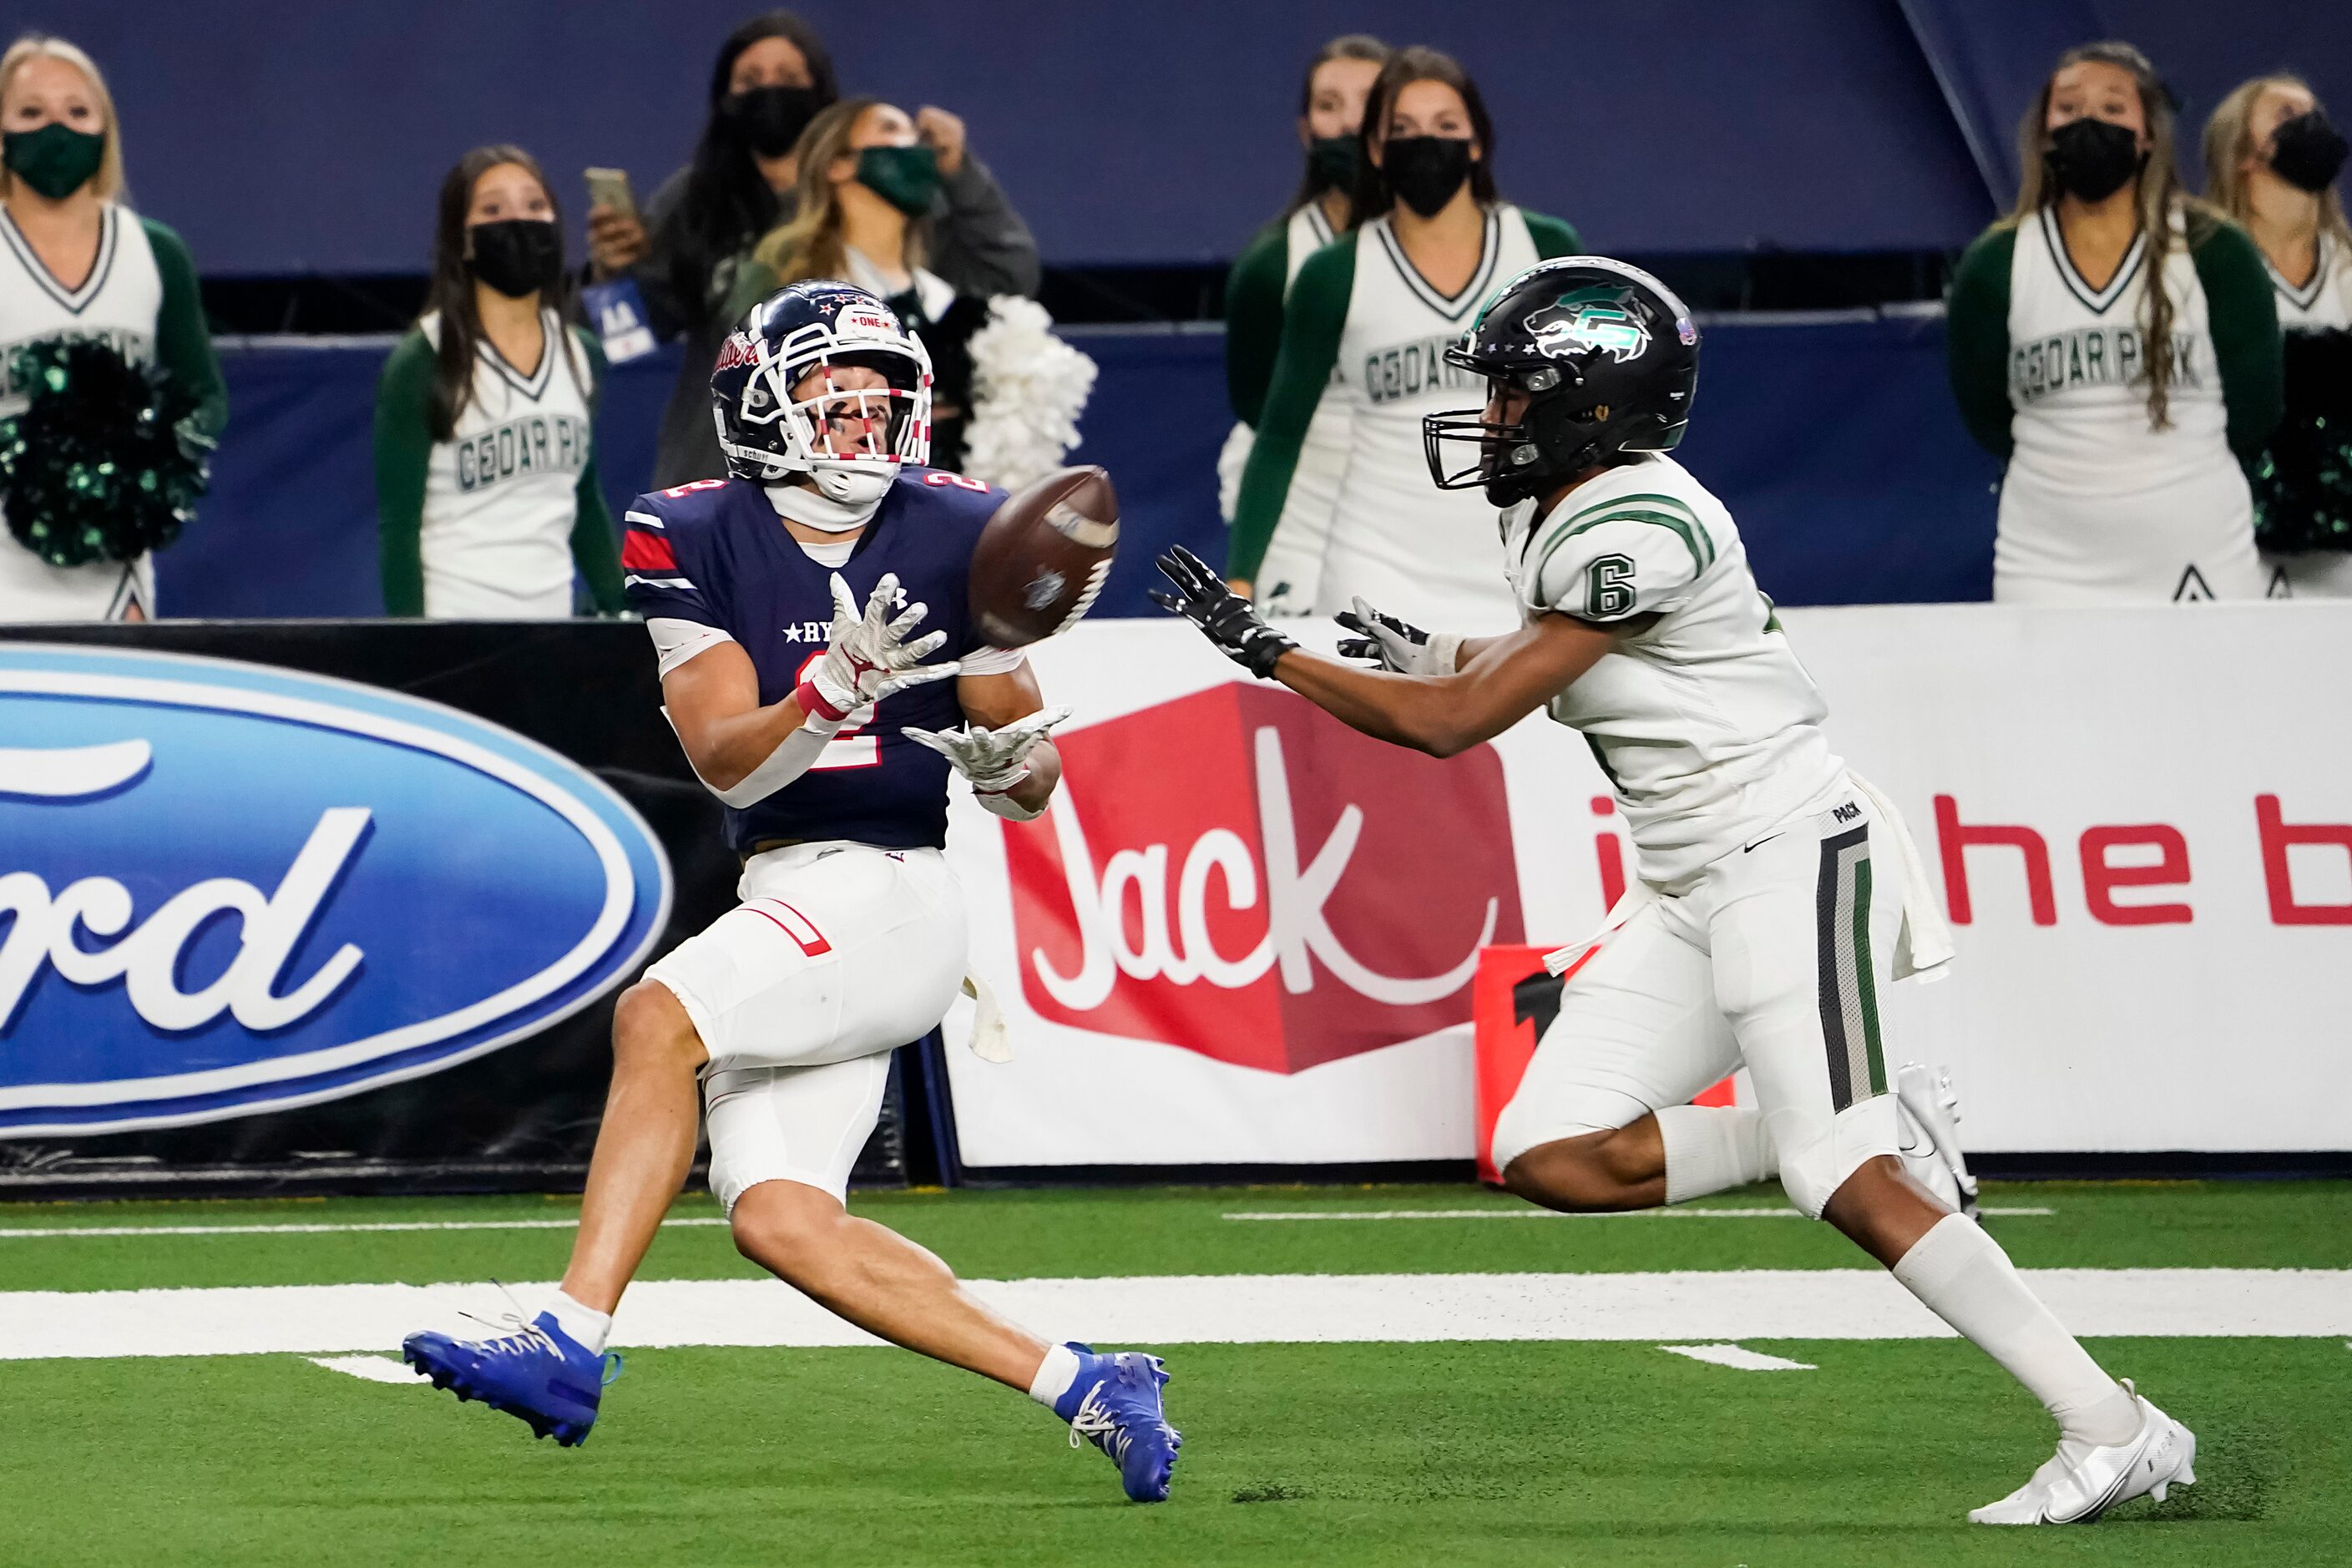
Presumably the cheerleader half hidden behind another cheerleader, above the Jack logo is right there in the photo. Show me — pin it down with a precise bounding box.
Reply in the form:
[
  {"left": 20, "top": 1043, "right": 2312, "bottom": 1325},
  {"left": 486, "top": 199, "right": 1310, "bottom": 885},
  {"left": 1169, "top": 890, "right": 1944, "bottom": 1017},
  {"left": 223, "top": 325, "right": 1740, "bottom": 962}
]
[{"left": 1216, "top": 33, "right": 1388, "bottom": 616}]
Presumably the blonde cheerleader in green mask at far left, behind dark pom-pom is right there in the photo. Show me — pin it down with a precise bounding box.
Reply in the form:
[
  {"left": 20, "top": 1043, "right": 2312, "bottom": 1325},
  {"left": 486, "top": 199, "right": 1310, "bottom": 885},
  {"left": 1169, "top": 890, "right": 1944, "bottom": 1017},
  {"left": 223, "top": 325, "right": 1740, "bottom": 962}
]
[{"left": 0, "top": 33, "right": 228, "bottom": 620}]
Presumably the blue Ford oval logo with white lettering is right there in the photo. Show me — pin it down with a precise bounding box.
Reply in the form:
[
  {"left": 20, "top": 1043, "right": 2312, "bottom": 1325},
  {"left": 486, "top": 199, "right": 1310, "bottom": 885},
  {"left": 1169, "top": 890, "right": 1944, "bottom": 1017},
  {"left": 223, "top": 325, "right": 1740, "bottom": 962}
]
[{"left": 0, "top": 644, "right": 670, "bottom": 1138}]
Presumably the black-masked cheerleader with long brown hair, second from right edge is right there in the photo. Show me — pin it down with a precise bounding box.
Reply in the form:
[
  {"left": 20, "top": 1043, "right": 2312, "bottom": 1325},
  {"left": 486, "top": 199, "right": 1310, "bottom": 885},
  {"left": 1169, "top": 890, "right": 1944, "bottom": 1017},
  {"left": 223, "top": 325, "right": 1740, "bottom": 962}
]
[{"left": 1947, "top": 43, "right": 2279, "bottom": 604}]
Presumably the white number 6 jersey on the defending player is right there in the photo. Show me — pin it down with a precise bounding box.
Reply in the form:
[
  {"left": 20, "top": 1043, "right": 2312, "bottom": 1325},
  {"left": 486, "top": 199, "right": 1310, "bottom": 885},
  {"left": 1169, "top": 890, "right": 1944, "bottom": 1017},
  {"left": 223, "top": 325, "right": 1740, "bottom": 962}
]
[{"left": 1500, "top": 453, "right": 1844, "bottom": 891}]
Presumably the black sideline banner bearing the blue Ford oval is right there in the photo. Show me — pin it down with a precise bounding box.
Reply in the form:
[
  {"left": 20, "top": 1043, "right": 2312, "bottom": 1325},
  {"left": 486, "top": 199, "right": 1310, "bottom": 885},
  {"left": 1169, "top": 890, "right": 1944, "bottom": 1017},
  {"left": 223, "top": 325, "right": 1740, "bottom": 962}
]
[{"left": 0, "top": 620, "right": 896, "bottom": 1192}]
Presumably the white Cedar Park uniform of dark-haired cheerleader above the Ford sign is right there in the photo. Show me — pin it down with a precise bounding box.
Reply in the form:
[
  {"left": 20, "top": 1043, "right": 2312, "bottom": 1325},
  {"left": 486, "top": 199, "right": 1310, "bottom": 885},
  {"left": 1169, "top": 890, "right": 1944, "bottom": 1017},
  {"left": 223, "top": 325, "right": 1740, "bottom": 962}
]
[{"left": 418, "top": 311, "right": 595, "bottom": 620}]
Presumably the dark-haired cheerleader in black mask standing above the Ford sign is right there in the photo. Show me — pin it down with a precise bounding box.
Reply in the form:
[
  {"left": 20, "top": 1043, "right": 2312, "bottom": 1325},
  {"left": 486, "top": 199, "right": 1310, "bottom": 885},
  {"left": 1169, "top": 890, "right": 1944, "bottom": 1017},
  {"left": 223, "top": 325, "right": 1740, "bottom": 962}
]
[{"left": 377, "top": 146, "right": 624, "bottom": 620}]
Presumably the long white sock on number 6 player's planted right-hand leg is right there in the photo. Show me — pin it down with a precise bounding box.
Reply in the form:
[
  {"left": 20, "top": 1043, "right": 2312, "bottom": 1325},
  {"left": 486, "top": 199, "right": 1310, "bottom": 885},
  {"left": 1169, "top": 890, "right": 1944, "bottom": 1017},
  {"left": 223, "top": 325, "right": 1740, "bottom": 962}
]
[{"left": 1894, "top": 1213, "right": 2140, "bottom": 1446}]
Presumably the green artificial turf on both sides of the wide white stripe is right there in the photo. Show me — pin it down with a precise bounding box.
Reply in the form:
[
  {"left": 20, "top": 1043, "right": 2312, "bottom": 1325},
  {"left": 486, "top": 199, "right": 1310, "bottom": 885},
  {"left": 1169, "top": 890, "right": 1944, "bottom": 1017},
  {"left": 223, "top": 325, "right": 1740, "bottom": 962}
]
[{"left": 0, "top": 1182, "right": 2352, "bottom": 1568}]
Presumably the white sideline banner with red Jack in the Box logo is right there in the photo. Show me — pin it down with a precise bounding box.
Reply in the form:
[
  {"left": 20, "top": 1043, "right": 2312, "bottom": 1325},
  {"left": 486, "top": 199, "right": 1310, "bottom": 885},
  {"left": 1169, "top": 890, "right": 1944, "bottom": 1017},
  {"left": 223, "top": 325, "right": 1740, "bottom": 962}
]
[{"left": 948, "top": 604, "right": 2352, "bottom": 1168}]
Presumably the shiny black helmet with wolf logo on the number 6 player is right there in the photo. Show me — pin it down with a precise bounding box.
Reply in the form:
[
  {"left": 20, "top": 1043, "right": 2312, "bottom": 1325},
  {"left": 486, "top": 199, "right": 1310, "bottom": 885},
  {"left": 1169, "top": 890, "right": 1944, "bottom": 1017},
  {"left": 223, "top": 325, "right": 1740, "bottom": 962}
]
[{"left": 1420, "top": 256, "right": 1698, "bottom": 505}]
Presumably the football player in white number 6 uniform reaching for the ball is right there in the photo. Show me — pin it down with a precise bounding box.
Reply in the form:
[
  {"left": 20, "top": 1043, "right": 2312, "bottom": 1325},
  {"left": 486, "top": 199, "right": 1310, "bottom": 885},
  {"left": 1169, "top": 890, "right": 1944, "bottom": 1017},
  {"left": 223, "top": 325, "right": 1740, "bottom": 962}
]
[{"left": 1160, "top": 256, "right": 2197, "bottom": 1524}]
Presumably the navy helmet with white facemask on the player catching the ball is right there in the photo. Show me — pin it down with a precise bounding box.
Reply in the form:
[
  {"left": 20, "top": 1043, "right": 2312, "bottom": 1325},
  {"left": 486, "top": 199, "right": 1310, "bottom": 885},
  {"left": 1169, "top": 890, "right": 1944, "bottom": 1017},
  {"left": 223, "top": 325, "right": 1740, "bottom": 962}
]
[{"left": 711, "top": 280, "right": 932, "bottom": 505}]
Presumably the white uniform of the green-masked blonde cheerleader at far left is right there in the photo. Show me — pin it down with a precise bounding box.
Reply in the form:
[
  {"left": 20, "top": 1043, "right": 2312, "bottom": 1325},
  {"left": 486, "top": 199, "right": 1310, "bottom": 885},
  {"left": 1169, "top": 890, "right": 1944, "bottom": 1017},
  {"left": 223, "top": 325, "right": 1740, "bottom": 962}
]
[{"left": 0, "top": 202, "right": 162, "bottom": 620}]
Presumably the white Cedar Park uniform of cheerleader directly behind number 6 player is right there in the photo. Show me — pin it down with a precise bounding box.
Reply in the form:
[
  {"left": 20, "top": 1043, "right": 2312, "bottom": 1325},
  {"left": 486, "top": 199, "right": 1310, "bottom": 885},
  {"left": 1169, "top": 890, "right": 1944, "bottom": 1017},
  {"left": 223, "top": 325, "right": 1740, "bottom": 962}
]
[{"left": 1319, "top": 205, "right": 1540, "bottom": 635}]
